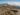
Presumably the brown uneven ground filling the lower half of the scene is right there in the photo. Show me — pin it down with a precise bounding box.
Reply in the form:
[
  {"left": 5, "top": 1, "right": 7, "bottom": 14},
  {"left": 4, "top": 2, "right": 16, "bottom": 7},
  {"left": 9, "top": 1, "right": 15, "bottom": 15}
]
[{"left": 0, "top": 7, "right": 20, "bottom": 15}]
